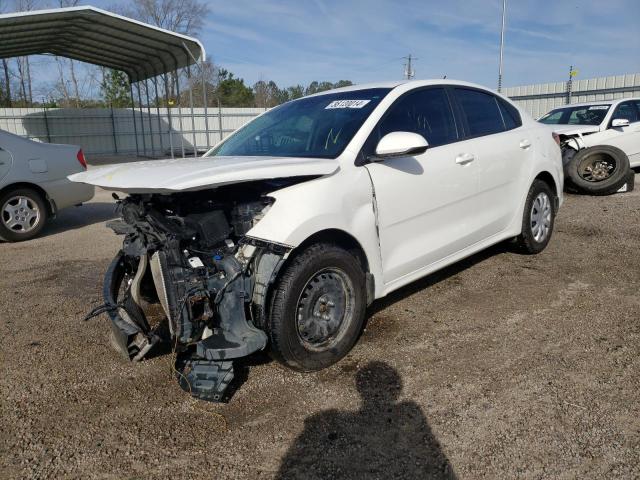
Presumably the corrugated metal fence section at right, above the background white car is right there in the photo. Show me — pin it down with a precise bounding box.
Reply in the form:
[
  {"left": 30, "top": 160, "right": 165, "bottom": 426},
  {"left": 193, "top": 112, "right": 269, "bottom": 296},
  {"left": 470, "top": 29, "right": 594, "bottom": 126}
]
[{"left": 503, "top": 73, "right": 640, "bottom": 118}]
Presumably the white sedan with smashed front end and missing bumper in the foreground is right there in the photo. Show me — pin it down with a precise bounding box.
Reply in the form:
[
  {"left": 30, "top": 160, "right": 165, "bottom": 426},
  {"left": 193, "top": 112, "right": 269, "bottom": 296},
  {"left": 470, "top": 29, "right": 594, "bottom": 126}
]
[{"left": 71, "top": 80, "right": 563, "bottom": 401}]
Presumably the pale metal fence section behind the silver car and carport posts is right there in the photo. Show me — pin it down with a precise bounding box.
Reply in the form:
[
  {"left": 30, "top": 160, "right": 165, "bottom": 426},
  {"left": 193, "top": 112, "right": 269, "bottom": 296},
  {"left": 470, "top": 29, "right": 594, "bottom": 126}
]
[{"left": 0, "top": 108, "right": 265, "bottom": 156}]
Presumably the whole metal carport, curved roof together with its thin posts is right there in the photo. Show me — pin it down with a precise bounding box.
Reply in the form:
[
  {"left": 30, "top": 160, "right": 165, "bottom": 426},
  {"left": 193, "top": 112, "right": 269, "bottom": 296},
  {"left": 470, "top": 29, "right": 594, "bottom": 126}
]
[{"left": 0, "top": 6, "right": 210, "bottom": 157}]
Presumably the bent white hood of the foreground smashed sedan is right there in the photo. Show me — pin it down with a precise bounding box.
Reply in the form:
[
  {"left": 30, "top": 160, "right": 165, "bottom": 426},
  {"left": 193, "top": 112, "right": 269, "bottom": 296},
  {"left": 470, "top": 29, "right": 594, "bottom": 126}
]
[{"left": 69, "top": 157, "right": 339, "bottom": 193}]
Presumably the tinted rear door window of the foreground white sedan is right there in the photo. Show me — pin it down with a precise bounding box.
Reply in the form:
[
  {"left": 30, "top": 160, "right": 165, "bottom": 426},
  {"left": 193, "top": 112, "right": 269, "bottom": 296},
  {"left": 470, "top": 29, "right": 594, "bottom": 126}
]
[{"left": 454, "top": 88, "right": 505, "bottom": 137}]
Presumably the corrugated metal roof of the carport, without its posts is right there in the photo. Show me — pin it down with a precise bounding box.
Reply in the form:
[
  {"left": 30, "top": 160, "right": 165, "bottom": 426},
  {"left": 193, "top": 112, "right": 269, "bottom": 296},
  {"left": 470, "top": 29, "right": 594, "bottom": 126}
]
[{"left": 0, "top": 6, "right": 206, "bottom": 82}]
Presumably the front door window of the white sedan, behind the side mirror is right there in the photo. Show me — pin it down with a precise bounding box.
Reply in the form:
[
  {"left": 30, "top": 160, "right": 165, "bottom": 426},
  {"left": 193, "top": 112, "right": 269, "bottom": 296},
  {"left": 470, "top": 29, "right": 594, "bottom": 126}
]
[{"left": 374, "top": 88, "right": 458, "bottom": 147}]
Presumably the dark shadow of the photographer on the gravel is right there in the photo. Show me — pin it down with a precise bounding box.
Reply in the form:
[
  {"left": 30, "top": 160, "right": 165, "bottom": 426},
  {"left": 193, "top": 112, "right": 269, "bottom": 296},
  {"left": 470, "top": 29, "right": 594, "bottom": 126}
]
[{"left": 276, "top": 362, "right": 456, "bottom": 480}]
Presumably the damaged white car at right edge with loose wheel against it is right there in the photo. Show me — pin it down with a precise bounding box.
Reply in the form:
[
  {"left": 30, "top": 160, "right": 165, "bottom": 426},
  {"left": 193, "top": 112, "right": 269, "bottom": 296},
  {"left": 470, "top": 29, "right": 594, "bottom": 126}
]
[{"left": 538, "top": 98, "right": 640, "bottom": 195}]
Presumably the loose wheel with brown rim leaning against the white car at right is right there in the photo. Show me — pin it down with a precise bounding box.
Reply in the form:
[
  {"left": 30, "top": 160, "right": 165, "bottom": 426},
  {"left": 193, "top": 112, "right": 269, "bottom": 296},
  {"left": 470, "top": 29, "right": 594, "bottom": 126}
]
[{"left": 565, "top": 145, "right": 629, "bottom": 195}]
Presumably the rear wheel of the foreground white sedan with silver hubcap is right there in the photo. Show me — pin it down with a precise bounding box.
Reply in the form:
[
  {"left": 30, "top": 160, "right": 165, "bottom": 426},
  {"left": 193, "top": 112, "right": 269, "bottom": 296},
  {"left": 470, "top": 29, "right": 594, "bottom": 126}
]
[{"left": 516, "top": 180, "right": 556, "bottom": 254}]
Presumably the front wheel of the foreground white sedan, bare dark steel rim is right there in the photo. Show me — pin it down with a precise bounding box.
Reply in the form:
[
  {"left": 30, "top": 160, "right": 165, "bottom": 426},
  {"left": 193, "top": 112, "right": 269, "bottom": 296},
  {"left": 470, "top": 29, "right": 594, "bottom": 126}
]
[{"left": 266, "top": 243, "right": 366, "bottom": 371}]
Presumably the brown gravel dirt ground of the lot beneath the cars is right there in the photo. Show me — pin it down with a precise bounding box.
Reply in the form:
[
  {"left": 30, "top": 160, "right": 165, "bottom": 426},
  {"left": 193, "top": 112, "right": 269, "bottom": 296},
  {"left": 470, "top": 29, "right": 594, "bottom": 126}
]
[{"left": 0, "top": 178, "right": 640, "bottom": 479}]
